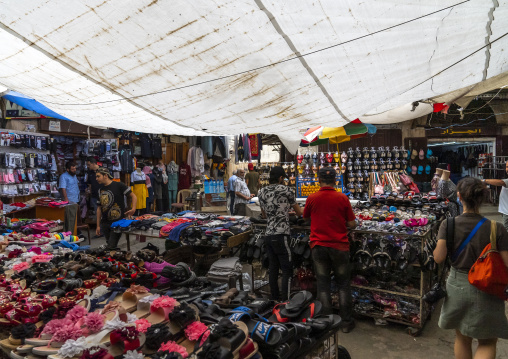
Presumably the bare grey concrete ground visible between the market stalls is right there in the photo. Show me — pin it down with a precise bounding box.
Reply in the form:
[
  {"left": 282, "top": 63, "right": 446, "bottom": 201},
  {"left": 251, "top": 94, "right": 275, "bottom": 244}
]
[{"left": 85, "top": 206, "right": 508, "bottom": 359}]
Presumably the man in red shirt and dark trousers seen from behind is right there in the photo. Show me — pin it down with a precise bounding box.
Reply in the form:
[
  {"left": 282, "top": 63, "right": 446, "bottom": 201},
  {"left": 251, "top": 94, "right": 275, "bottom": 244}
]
[{"left": 303, "top": 167, "right": 356, "bottom": 333}]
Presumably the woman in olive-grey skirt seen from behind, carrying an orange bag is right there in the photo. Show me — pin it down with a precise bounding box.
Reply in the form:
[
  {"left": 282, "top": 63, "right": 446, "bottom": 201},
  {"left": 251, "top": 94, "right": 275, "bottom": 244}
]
[{"left": 434, "top": 177, "right": 508, "bottom": 359}]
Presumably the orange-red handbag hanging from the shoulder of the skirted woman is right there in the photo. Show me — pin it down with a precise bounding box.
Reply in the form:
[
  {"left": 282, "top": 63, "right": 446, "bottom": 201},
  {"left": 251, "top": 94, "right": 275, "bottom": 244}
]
[{"left": 468, "top": 221, "right": 508, "bottom": 300}]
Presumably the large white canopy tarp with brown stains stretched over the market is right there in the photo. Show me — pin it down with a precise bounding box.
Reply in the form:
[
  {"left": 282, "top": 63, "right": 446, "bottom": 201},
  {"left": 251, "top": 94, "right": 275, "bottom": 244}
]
[{"left": 0, "top": 0, "right": 508, "bottom": 151}]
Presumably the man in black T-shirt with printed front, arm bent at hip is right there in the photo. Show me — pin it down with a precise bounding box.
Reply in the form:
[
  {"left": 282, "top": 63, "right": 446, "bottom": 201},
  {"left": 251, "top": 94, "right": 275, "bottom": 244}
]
[{"left": 96, "top": 167, "right": 137, "bottom": 250}]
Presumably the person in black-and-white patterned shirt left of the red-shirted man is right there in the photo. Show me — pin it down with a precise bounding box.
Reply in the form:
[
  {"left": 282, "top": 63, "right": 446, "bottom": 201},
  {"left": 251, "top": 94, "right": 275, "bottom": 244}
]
[{"left": 258, "top": 167, "right": 302, "bottom": 301}]
